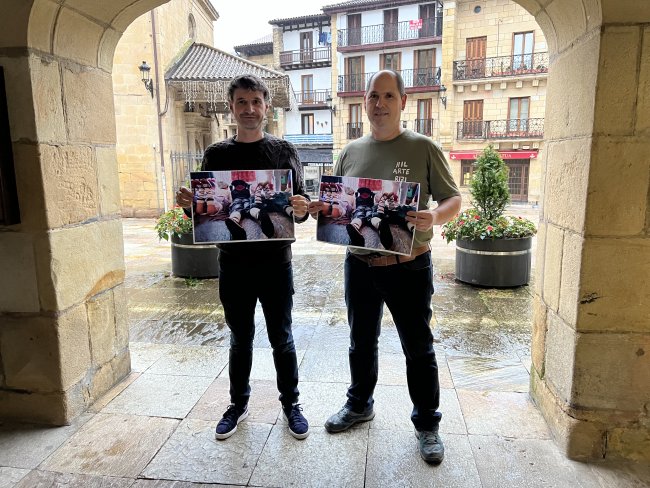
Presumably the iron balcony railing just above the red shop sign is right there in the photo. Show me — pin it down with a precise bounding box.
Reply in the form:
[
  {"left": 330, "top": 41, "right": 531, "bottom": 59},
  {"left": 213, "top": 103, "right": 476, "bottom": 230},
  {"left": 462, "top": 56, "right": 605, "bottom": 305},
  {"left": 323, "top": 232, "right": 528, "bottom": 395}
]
[{"left": 456, "top": 119, "right": 544, "bottom": 139}]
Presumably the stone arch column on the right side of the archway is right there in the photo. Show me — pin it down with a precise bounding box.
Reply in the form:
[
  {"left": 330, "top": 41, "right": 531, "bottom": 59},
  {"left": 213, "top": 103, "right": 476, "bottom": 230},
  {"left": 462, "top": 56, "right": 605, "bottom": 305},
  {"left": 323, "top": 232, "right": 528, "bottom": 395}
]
[{"left": 516, "top": 0, "right": 650, "bottom": 461}]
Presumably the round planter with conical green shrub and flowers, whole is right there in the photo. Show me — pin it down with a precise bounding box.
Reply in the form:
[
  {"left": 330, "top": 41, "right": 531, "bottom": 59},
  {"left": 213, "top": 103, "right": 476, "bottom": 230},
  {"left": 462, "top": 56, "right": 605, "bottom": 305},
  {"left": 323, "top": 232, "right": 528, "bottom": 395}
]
[{"left": 442, "top": 145, "right": 537, "bottom": 287}]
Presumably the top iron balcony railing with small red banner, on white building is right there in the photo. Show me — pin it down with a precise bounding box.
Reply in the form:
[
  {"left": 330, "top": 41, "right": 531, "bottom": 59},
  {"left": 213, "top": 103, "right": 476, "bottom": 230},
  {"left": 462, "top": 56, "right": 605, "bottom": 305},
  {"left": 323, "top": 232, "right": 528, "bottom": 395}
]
[{"left": 338, "top": 17, "right": 442, "bottom": 47}]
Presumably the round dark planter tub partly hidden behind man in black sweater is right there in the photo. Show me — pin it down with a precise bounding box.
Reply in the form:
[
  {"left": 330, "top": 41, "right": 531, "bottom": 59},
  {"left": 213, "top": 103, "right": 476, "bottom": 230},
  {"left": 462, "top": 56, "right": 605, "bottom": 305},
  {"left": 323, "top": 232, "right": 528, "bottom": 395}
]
[{"left": 171, "top": 234, "right": 219, "bottom": 278}]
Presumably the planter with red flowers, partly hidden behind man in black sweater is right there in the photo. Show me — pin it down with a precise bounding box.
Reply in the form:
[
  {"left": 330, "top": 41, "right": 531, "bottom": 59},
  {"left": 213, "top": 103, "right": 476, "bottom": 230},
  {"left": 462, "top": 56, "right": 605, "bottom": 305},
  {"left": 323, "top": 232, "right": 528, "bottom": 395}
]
[{"left": 154, "top": 207, "right": 219, "bottom": 278}]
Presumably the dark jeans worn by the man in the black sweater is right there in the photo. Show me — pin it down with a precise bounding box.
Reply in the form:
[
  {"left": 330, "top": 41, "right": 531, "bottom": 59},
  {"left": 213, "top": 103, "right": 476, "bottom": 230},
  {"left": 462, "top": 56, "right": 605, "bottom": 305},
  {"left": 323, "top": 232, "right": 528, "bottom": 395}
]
[{"left": 219, "top": 254, "right": 298, "bottom": 406}]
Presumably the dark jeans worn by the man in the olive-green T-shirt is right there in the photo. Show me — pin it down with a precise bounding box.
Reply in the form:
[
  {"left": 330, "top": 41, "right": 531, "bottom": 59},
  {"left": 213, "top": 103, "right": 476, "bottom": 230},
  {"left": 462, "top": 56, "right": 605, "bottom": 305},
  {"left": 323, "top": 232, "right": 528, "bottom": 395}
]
[{"left": 345, "top": 252, "right": 442, "bottom": 430}]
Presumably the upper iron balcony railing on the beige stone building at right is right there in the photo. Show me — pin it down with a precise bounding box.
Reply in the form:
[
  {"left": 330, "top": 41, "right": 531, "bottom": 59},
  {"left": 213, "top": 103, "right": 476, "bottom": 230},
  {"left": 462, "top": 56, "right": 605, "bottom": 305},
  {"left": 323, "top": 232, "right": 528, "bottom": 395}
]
[{"left": 454, "top": 53, "right": 548, "bottom": 81}]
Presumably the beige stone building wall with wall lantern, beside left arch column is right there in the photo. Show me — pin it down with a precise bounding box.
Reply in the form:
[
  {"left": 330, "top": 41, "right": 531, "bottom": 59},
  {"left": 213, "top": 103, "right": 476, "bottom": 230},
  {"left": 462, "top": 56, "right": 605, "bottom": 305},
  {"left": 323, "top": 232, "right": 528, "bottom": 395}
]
[{"left": 113, "top": 0, "right": 216, "bottom": 217}]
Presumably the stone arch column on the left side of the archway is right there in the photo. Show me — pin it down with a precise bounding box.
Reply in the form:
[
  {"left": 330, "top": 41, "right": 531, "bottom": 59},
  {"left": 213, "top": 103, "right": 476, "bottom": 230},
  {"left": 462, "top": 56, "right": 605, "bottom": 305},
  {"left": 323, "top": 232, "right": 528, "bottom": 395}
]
[{"left": 0, "top": 0, "right": 170, "bottom": 425}]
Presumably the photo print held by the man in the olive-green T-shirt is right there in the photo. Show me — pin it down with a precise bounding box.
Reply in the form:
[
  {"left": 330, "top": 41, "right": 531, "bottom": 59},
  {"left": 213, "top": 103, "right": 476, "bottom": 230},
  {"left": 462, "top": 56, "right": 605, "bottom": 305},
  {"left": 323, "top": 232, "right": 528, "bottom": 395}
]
[{"left": 316, "top": 176, "right": 420, "bottom": 255}]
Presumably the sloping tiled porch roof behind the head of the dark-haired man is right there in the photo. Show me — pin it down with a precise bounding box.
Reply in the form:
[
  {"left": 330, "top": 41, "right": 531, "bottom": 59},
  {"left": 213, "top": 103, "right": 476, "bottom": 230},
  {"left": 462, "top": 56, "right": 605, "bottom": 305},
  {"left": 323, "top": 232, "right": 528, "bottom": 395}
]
[{"left": 165, "top": 43, "right": 287, "bottom": 82}]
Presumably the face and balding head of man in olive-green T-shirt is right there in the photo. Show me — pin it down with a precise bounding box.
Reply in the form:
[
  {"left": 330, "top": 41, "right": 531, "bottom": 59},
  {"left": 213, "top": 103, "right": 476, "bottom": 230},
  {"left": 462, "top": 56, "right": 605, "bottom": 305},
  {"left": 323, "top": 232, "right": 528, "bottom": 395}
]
[{"left": 364, "top": 73, "right": 406, "bottom": 129}]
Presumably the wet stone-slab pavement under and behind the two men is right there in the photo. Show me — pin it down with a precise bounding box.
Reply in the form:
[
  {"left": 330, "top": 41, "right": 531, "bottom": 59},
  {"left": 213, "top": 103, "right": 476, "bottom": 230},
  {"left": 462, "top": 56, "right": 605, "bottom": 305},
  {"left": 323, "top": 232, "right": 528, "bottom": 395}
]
[{"left": 0, "top": 208, "right": 650, "bottom": 488}]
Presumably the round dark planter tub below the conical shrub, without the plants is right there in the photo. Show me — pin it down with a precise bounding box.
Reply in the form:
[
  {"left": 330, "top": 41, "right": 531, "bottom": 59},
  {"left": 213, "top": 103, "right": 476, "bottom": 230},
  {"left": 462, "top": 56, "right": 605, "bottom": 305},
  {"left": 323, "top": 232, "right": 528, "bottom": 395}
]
[{"left": 456, "top": 237, "right": 533, "bottom": 287}]
